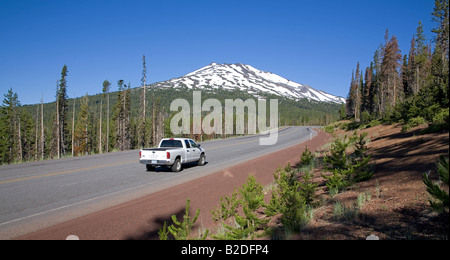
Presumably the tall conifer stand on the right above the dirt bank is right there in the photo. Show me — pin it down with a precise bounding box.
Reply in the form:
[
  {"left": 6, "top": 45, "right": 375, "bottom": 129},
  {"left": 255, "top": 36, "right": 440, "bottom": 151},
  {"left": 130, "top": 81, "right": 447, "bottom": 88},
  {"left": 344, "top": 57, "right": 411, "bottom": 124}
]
[{"left": 341, "top": 0, "right": 449, "bottom": 130}]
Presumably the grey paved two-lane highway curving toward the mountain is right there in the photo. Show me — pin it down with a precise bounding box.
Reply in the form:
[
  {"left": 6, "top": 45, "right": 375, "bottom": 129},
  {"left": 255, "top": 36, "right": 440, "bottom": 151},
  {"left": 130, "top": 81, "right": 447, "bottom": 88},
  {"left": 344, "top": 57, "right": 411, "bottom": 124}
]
[{"left": 0, "top": 127, "right": 316, "bottom": 239}]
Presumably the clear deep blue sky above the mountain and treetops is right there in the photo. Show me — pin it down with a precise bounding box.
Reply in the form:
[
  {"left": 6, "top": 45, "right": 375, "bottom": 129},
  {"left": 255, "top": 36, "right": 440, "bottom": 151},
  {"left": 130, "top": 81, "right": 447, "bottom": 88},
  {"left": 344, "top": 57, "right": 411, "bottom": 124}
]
[{"left": 0, "top": 0, "right": 435, "bottom": 104}]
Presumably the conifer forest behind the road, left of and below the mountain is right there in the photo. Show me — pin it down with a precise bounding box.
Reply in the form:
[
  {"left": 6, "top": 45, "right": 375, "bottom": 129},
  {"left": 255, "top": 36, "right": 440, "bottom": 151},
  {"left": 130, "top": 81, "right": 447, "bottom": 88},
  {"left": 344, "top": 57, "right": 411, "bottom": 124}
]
[{"left": 0, "top": 76, "right": 341, "bottom": 164}]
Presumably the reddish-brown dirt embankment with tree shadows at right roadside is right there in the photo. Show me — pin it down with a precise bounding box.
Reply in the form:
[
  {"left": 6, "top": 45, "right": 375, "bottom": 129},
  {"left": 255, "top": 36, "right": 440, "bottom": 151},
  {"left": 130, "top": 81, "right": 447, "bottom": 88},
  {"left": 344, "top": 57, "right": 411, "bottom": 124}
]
[{"left": 293, "top": 124, "right": 449, "bottom": 239}]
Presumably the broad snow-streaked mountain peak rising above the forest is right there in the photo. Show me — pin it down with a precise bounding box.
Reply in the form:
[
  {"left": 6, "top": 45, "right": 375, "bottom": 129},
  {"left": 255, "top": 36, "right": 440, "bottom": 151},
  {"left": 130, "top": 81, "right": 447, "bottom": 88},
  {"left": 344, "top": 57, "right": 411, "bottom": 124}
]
[{"left": 156, "top": 63, "right": 345, "bottom": 103}]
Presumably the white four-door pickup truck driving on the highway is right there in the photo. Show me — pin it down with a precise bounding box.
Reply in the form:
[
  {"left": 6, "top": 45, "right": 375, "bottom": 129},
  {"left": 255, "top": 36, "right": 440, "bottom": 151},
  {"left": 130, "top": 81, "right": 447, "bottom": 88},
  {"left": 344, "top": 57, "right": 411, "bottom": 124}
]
[{"left": 139, "top": 138, "right": 206, "bottom": 172}]
